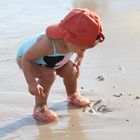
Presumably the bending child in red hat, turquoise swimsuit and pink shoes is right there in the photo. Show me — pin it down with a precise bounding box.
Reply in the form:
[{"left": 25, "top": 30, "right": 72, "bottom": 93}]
[{"left": 17, "top": 8, "right": 104, "bottom": 123}]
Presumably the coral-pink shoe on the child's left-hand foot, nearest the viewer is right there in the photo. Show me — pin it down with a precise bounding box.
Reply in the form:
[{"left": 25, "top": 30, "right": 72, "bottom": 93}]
[{"left": 33, "top": 105, "right": 58, "bottom": 123}]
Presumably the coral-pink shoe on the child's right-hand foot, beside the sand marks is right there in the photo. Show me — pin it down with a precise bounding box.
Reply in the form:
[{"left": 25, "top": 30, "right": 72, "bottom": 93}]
[{"left": 68, "top": 92, "right": 90, "bottom": 107}]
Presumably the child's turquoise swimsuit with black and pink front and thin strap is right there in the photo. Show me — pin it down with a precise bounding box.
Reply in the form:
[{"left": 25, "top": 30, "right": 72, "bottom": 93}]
[{"left": 17, "top": 33, "right": 73, "bottom": 69}]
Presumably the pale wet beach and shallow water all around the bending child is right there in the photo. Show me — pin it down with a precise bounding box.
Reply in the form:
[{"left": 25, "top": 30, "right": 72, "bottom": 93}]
[{"left": 0, "top": 0, "right": 140, "bottom": 140}]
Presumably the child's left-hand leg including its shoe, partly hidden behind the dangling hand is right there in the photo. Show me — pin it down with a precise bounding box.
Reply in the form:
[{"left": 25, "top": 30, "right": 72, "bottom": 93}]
[{"left": 17, "top": 58, "right": 57, "bottom": 122}]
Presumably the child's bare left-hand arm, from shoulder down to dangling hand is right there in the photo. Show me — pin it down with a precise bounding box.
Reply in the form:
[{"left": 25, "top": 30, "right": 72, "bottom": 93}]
[{"left": 22, "top": 37, "right": 49, "bottom": 95}]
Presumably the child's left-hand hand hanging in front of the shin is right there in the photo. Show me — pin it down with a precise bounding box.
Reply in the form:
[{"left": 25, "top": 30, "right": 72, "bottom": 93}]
[{"left": 28, "top": 83, "right": 46, "bottom": 97}]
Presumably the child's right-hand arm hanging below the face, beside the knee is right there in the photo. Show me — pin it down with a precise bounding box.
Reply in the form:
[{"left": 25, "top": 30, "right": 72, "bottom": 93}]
[{"left": 74, "top": 51, "right": 85, "bottom": 78}]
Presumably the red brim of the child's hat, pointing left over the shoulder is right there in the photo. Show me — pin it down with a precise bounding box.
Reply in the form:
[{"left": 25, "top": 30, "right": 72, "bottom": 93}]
[{"left": 46, "top": 24, "right": 63, "bottom": 39}]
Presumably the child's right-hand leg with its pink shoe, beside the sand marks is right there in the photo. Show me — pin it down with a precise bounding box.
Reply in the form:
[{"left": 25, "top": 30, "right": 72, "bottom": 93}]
[{"left": 57, "top": 61, "right": 90, "bottom": 106}]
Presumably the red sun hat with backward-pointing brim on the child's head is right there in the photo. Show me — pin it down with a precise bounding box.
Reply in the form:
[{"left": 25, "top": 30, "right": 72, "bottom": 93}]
[{"left": 46, "top": 8, "right": 105, "bottom": 46}]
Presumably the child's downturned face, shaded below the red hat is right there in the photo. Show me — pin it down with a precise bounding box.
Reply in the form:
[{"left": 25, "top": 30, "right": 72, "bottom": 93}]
[{"left": 65, "top": 40, "right": 99, "bottom": 53}]
